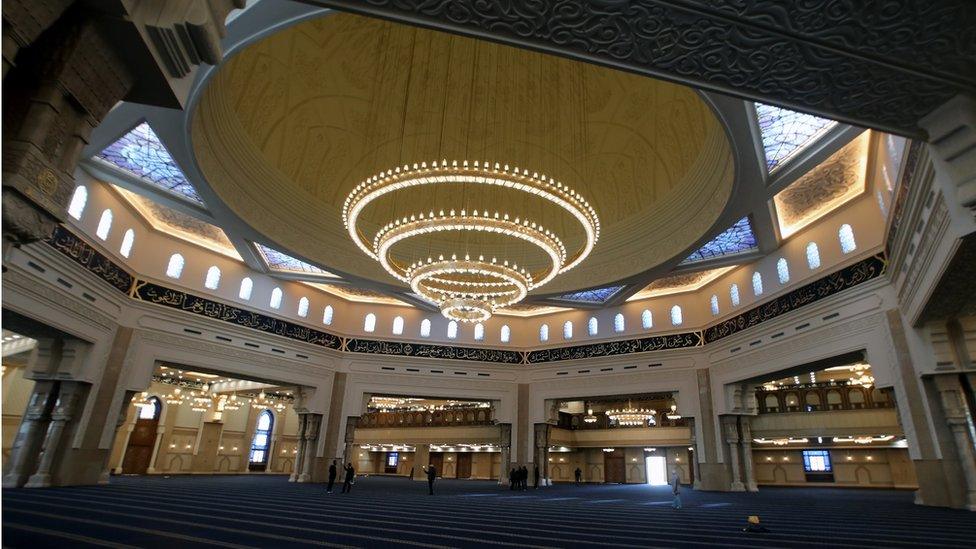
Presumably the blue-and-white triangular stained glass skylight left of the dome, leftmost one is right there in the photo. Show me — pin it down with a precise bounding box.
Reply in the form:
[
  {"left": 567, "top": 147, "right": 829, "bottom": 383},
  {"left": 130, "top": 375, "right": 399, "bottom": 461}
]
[{"left": 97, "top": 122, "right": 203, "bottom": 204}]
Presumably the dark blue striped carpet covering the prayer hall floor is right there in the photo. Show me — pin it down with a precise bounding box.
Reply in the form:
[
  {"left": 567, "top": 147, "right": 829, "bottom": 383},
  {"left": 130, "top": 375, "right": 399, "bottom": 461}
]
[{"left": 3, "top": 476, "right": 976, "bottom": 548}]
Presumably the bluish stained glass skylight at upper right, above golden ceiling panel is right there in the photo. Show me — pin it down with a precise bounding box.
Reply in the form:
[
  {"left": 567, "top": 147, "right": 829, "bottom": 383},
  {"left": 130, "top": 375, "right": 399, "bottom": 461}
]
[{"left": 756, "top": 103, "right": 837, "bottom": 173}]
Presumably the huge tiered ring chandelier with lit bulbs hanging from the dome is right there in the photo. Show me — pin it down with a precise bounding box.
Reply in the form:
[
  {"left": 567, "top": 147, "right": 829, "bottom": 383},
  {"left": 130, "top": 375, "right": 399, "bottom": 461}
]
[{"left": 342, "top": 160, "right": 600, "bottom": 322}]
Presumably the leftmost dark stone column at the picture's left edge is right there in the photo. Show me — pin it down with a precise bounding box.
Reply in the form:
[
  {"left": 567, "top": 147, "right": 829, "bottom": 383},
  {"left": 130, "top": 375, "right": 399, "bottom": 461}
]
[{"left": 3, "top": 381, "right": 59, "bottom": 488}]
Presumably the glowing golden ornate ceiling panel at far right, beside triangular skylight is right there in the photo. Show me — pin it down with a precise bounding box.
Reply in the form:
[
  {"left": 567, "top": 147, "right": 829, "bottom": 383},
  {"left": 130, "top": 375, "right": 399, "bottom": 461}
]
[{"left": 773, "top": 132, "right": 870, "bottom": 238}]
